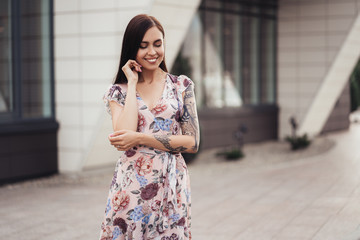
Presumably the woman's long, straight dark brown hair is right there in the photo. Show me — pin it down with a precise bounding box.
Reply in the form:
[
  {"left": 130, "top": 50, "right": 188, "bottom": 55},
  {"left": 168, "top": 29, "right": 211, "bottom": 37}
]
[{"left": 114, "top": 14, "right": 167, "bottom": 84}]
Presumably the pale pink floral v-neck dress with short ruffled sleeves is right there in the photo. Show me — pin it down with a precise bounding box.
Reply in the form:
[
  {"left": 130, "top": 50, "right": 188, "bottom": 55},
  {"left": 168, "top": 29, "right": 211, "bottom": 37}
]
[{"left": 100, "top": 74, "right": 193, "bottom": 240}]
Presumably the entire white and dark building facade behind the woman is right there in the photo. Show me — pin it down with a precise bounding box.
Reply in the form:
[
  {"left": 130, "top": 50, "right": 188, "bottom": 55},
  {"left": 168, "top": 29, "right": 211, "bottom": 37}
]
[{"left": 0, "top": 0, "right": 360, "bottom": 181}]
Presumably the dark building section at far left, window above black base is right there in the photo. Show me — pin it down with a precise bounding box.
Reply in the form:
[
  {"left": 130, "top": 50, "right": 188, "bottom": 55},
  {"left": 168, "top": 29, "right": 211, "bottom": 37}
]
[{"left": 0, "top": 0, "right": 58, "bottom": 183}]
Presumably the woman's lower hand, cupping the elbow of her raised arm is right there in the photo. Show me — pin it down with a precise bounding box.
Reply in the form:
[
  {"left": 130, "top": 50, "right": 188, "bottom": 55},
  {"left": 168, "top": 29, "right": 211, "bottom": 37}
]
[{"left": 109, "top": 130, "right": 140, "bottom": 151}]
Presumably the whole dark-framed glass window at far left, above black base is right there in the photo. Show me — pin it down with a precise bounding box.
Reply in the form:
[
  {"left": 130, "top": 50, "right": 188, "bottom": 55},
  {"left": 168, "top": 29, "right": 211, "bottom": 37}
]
[{"left": 0, "top": 0, "right": 53, "bottom": 122}]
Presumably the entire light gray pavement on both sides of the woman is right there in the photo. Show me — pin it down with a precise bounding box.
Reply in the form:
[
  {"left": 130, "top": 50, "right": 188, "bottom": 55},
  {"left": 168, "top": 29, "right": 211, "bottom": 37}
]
[{"left": 0, "top": 124, "right": 360, "bottom": 240}]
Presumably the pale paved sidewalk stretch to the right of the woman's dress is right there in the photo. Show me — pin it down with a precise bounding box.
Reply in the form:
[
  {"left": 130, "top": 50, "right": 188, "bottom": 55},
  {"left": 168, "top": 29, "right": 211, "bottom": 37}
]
[{"left": 191, "top": 125, "right": 360, "bottom": 240}]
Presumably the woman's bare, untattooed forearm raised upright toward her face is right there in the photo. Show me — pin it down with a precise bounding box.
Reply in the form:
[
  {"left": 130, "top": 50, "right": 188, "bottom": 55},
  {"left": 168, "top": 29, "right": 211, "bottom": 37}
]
[{"left": 113, "top": 84, "right": 138, "bottom": 132}]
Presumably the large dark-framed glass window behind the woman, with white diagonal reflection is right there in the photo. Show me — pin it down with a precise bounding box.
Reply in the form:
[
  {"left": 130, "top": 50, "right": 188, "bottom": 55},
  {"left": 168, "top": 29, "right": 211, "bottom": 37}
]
[{"left": 173, "top": 0, "right": 277, "bottom": 108}]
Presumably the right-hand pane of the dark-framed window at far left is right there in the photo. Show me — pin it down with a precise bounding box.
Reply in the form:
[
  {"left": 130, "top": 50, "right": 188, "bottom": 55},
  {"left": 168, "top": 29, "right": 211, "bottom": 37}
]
[{"left": 21, "top": 0, "right": 51, "bottom": 118}]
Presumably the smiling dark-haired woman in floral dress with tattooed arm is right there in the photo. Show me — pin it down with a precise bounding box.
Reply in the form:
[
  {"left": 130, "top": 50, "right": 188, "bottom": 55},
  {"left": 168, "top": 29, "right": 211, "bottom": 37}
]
[{"left": 100, "top": 15, "right": 199, "bottom": 240}]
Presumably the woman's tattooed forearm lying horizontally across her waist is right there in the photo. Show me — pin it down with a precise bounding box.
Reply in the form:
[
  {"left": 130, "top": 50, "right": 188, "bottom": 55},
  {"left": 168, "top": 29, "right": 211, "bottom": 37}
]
[{"left": 139, "top": 133, "right": 198, "bottom": 153}]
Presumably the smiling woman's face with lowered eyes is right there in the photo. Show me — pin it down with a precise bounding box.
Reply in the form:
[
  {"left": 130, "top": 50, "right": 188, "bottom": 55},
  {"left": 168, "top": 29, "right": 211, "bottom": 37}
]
[{"left": 135, "top": 26, "right": 164, "bottom": 70}]
